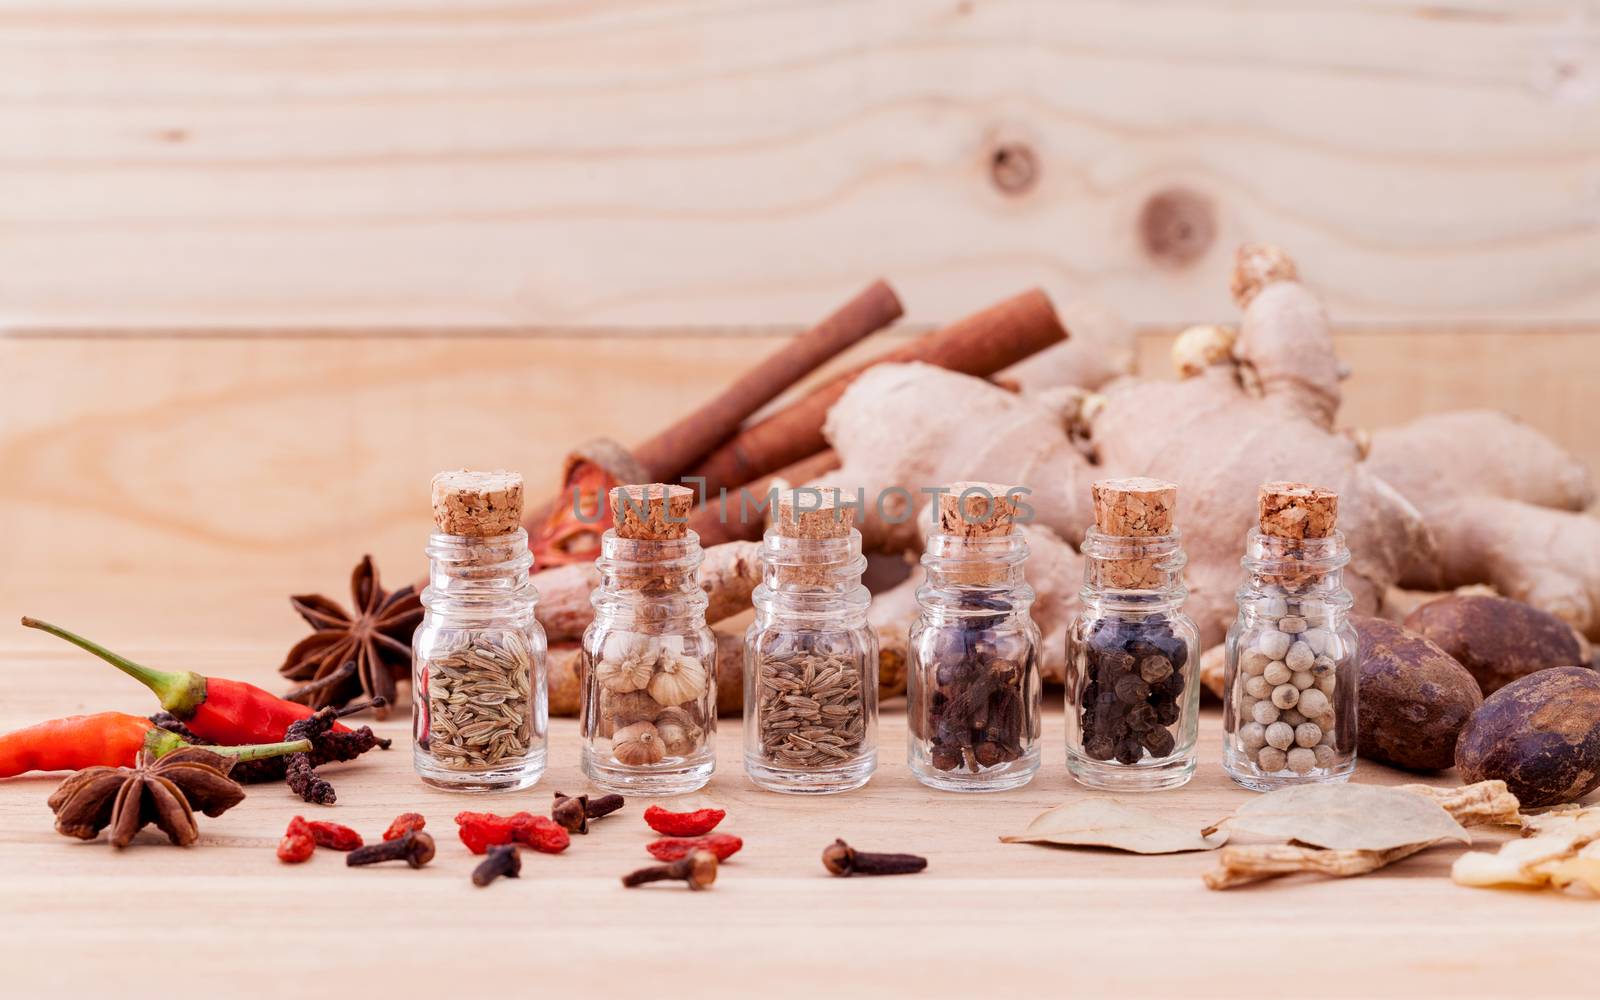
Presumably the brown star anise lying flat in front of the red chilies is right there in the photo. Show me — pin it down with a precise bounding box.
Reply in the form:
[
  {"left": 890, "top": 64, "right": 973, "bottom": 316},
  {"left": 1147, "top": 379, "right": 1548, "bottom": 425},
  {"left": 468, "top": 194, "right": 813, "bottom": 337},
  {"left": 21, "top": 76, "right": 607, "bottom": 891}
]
[{"left": 50, "top": 747, "right": 245, "bottom": 848}]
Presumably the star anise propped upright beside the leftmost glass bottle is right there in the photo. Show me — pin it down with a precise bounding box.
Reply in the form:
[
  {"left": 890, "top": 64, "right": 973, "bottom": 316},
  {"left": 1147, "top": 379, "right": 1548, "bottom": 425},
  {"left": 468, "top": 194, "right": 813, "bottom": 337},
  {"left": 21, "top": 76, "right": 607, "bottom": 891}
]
[{"left": 278, "top": 555, "right": 422, "bottom": 718}]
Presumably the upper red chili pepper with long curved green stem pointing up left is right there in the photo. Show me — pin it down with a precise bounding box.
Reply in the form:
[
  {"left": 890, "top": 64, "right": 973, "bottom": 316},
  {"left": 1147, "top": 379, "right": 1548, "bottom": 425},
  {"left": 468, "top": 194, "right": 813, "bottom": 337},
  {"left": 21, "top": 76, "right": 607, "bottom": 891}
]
[{"left": 22, "top": 618, "right": 350, "bottom": 744}]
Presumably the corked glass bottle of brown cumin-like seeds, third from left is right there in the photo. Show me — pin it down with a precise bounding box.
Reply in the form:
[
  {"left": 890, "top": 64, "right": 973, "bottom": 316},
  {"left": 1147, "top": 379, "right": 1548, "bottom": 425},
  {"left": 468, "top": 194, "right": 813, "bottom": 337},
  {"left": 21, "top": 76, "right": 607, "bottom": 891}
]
[{"left": 744, "top": 488, "right": 878, "bottom": 792}]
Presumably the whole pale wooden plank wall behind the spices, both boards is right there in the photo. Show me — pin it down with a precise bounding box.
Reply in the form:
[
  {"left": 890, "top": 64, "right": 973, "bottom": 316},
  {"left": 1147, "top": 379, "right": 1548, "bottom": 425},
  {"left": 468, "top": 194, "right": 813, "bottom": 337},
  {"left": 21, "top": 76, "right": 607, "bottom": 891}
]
[{"left": 0, "top": 0, "right": 1600, "bottom": 643}]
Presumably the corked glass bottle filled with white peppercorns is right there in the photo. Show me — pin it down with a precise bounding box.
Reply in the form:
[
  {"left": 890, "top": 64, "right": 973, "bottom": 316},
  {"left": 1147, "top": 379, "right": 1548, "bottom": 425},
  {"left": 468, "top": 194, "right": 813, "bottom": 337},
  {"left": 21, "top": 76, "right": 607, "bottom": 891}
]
[{"left": 1222, "top": 483, "right": 1358, "bottom": 790}]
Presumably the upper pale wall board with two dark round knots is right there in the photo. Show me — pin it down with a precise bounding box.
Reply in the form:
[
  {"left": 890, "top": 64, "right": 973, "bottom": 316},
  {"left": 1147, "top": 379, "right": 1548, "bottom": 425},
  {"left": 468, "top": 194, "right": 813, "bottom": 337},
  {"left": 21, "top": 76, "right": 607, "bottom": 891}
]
[{"left": 0, "top": 0, "right": 1600, "bottom": 326}]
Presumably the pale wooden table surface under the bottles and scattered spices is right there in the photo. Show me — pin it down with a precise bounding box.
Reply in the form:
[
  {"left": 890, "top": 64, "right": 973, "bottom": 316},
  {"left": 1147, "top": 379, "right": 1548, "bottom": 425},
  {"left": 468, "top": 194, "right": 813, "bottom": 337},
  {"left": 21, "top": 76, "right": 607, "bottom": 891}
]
[{"left": 0, "top": 643, "right": 1600, "bottom": 998}]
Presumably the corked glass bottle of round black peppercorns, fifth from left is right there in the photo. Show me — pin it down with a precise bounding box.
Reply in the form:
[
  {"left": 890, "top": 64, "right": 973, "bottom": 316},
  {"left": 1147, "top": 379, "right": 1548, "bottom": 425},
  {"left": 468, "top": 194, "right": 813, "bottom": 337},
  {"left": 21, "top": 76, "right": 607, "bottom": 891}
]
[{"left": 1067, "top": 477, "right": 1200, "bottom": 790}]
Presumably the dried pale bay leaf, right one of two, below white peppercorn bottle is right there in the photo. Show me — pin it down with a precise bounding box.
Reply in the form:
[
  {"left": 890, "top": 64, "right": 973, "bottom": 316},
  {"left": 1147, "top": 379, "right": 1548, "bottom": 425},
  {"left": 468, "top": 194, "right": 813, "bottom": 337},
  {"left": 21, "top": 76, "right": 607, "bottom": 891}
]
[{"left": 1210, "top": 784, "right": 1472, "bottom": 851}]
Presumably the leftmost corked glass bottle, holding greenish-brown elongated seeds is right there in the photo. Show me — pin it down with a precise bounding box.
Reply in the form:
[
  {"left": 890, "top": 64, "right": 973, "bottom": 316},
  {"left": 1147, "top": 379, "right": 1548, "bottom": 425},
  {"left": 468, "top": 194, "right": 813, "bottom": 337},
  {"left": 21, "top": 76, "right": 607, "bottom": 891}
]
[{"left": 411, "top": 470, "right": 549, "bottom": 792}]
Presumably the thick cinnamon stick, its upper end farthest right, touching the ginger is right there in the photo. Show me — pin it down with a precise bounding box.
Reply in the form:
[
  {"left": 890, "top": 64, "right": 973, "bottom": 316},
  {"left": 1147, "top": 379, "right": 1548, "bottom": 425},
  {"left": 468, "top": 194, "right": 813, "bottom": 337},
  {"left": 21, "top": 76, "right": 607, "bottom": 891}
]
[{"left": 686, "top": 288, "right": 1067, "bottom": 496}]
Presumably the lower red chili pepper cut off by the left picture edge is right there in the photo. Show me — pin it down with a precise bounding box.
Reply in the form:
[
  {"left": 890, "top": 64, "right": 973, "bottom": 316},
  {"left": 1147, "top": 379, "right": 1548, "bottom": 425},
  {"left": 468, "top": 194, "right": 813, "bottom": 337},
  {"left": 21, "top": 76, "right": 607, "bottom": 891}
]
[{"left": 0, "top": 712, "right": 310, "bottom": 778}]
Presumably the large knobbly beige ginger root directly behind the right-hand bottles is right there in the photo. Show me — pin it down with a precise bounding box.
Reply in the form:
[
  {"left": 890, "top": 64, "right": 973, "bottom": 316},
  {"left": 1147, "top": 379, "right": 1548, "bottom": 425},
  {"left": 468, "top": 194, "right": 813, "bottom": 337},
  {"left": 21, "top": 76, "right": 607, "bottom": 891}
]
[{"left": 826, "top": 248, "right": 1434, "bottom": 645}]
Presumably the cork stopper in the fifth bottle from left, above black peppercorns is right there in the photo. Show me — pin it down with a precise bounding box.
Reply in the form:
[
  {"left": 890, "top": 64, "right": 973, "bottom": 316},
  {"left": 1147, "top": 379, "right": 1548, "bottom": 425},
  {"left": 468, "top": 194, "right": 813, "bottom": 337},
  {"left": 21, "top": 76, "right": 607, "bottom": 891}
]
[{"left": 1090, "top": 477, "right": 1178, "bottom": 590}]
